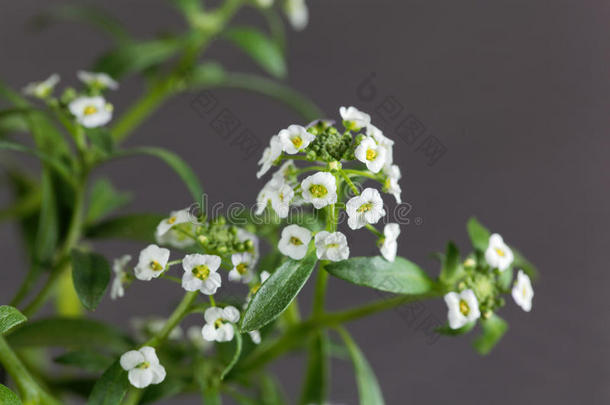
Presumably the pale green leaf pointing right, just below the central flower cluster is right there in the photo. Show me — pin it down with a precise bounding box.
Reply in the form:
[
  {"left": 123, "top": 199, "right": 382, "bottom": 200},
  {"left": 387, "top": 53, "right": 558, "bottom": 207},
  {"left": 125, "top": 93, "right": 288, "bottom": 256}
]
[{"left": 324, "top": 256, "right": 435, "bottom": 294}]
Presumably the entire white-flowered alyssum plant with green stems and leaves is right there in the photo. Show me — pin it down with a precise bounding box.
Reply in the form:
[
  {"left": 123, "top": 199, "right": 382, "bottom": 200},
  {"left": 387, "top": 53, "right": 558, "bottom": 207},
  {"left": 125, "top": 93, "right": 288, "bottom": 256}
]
[{"left": 0, "top": 0, "right": 535, "bottom": 405}]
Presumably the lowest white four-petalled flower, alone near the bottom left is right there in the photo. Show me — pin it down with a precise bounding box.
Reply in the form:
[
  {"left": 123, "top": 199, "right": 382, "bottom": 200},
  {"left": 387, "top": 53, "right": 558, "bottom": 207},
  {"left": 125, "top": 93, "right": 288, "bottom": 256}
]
[{"left": 120, "top": 346, "right": 165, "bottom": 388}]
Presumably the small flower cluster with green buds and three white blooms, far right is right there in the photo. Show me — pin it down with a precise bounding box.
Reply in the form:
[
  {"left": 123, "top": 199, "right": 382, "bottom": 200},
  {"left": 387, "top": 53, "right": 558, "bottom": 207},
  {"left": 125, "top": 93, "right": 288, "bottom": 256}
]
[{"left": 445, "top": 233, "right": 534, "bottom": 329}]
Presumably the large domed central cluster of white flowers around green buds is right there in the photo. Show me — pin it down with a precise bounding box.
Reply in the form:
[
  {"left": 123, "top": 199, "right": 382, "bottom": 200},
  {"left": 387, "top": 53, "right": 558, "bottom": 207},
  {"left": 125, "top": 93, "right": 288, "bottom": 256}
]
[{"left": 257, "top": 107, "right": 401, "bottom": 261}]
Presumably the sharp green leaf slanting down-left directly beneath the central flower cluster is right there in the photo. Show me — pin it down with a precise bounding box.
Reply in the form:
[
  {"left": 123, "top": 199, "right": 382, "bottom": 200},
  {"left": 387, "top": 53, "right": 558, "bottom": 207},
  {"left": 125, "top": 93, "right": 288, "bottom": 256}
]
[{"left": 240, "top": 251, "right": 316, "bottom": 332}]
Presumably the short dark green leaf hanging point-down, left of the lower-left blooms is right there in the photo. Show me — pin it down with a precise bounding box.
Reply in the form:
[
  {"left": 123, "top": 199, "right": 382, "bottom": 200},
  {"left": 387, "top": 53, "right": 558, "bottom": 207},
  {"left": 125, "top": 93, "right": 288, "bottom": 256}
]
[{"left": 71, "top": 250, "right": 110, "bottom": 311}]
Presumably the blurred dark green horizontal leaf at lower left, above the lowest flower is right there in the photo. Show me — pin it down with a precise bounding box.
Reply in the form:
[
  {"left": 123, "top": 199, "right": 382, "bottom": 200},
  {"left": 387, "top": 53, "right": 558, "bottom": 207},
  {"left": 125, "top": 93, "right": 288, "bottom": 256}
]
[{"left": 7, "top": 318, "right": 131, "bottom": 353}]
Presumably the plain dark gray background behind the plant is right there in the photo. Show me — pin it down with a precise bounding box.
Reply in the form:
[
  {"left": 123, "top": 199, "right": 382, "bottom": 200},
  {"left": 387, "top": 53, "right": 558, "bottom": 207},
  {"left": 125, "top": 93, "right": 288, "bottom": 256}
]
[{"left": 0, "top": 0, "right": 610, "bottom": 404}]
